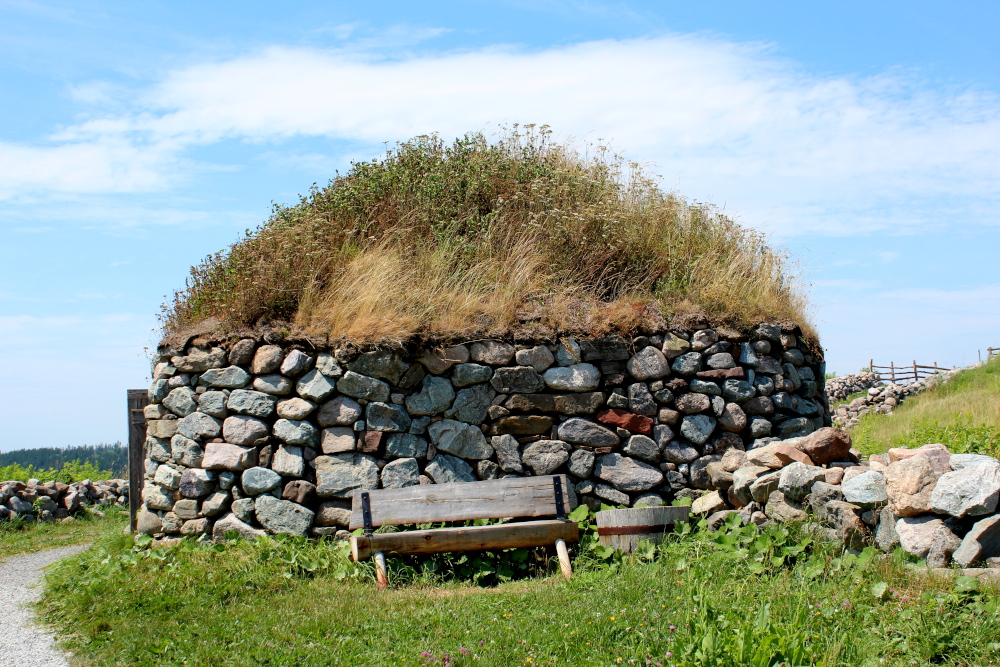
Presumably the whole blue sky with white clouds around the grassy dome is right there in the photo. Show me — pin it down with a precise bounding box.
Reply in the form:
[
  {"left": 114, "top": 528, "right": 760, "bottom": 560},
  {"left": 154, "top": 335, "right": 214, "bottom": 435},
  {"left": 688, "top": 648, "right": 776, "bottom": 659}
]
[{"left": 0, "top": 1, "right": 1000, "bottom": 450}]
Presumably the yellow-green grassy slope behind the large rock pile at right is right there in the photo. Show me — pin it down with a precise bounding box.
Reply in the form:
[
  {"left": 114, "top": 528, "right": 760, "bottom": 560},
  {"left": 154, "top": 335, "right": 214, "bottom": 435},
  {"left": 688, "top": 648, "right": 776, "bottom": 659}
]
[{"left": 851, "top": 359, "right": 1000, "bottom": 456}]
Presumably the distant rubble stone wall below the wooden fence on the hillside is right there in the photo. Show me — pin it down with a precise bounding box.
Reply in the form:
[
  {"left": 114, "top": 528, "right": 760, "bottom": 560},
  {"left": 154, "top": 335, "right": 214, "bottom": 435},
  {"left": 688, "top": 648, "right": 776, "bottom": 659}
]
[{"left": 826, "top": 368, "right": 965, "bottom": 428}]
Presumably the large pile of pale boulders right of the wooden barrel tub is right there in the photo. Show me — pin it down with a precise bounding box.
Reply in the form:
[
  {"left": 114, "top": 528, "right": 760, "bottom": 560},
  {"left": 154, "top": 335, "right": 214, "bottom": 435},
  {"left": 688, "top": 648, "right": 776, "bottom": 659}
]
[{"left": 692, "top": 428, "right": 1000, "bottom": 567}]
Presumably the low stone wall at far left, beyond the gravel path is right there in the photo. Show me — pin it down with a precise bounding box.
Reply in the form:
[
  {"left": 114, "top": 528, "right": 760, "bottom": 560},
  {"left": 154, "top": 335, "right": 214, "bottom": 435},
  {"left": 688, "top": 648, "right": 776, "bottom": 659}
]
[{"left": 0, "top": 479, "right": 128, "bottom": 522}]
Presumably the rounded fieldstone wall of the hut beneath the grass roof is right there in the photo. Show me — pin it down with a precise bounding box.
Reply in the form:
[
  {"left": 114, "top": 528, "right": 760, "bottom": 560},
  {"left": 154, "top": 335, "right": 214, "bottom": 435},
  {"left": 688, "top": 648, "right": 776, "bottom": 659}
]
[{"left": 139, "top": 323, "right": 830, "bottom": 537}]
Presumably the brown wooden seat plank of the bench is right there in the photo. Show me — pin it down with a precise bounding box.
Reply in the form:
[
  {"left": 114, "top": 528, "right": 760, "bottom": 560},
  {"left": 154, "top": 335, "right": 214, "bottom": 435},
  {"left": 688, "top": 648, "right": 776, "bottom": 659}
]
[{"left": 351, "top": 519, "right": 580, "bottom": 561}]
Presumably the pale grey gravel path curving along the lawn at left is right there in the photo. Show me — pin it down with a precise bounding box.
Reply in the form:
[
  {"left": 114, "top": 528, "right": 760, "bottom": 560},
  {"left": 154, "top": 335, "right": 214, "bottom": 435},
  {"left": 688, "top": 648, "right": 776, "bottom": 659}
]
[{"left": 0, "top": 544, "right": 89, "bottom": 667}]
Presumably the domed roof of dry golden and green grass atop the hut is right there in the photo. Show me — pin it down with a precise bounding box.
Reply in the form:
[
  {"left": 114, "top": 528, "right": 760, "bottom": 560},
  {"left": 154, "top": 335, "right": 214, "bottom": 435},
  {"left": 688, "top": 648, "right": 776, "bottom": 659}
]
[{"left": 163, "top": 127, "right": 804, "bottom": 344}]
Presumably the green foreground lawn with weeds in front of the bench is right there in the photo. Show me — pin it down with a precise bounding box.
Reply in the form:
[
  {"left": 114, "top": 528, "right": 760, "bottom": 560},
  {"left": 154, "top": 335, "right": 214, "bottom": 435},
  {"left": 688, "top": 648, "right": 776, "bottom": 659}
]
[{"left": 42, "top": 520, "right": 1000, "bottom": 667}]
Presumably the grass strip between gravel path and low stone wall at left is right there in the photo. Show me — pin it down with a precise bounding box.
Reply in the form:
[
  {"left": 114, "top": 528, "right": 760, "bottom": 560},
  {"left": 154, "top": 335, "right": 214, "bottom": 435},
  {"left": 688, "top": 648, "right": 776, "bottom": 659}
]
[{"left": 0, "top": 509, "right": 128, "bottom": 559}]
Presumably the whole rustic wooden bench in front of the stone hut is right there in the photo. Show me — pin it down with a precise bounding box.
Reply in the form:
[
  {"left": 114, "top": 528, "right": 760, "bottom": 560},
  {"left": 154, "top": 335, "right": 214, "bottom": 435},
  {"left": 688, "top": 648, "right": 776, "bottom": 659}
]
[{"left": 351, "top": 475, "right": 580, "bottom": 588}]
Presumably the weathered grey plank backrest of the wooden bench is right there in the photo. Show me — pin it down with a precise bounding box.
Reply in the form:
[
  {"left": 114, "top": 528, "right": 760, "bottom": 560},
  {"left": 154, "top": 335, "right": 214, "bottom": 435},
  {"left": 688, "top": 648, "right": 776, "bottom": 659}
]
[{"left": 351, "top": 475, "right": 570, "bottom": 530}]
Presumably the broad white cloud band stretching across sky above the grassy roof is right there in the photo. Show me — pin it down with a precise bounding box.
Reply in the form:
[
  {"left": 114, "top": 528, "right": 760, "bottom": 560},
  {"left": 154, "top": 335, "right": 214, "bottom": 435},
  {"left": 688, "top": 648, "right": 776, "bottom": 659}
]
[{"left": 0, "top": 35, "right": 1000, "bottom": 235}]
